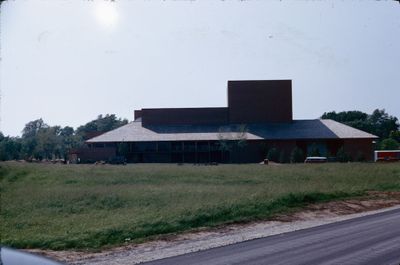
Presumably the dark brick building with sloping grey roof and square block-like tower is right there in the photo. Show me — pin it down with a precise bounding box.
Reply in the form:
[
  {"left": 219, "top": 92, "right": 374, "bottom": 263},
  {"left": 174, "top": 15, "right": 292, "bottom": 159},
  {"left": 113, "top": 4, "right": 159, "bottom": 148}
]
[{"left": 83, "top": 80, "right": 377, "bottom": 163}]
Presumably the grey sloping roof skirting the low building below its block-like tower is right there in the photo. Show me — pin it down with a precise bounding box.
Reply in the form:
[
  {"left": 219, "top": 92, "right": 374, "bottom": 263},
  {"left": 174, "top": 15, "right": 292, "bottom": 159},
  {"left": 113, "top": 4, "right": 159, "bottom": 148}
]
[{"left": 86, "top": 119, "right": 378, "bottom": 143}]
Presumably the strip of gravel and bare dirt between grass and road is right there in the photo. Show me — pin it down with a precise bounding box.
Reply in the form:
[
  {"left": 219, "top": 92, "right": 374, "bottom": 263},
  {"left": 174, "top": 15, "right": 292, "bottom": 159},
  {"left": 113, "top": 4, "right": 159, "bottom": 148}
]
[{"left": 29, "top": 192, "right": 400, "bottom": 265}]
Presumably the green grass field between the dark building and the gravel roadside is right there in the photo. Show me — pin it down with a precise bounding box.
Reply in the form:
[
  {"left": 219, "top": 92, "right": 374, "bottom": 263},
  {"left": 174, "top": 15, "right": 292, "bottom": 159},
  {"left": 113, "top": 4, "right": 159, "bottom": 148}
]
[{"left": 0, "top": 162, "right": 400, "bottom": 249}]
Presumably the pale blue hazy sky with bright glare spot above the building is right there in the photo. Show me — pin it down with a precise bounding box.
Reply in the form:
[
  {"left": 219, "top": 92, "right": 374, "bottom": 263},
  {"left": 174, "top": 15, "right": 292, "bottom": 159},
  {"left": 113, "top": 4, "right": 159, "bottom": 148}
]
[{"left": 0, "top": 0, "right": 400, "bottom": 136}]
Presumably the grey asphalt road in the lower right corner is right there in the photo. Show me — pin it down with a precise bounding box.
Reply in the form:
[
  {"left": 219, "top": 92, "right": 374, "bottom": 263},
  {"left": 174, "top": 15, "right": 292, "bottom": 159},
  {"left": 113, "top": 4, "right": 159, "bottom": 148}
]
[{"left": 144, "top": 209, "right": 400, "bottom": 265}]
